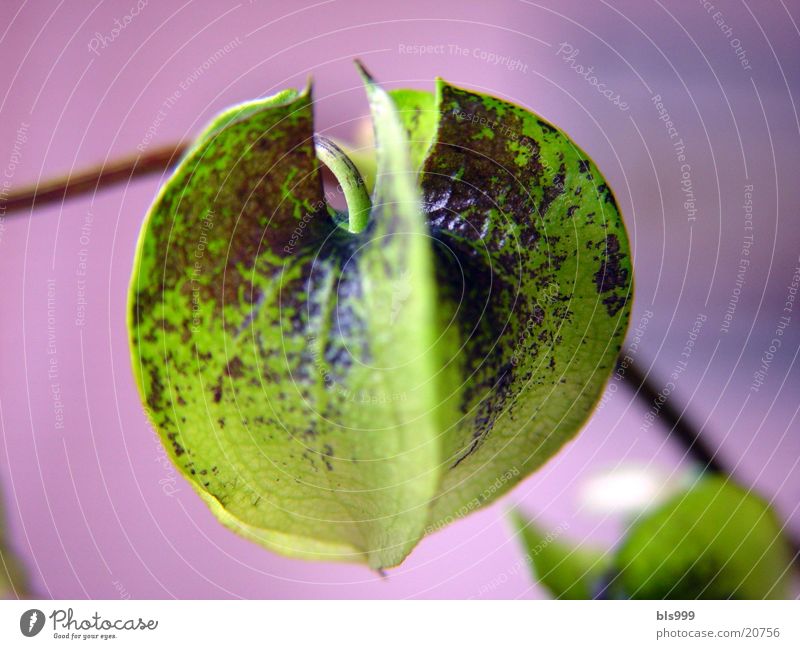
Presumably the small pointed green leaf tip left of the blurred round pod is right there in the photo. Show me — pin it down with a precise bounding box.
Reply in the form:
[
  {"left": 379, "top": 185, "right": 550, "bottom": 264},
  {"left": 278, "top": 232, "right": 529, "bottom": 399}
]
[{"left": 512, "top": 512, "right": 609, "bottom": 599}]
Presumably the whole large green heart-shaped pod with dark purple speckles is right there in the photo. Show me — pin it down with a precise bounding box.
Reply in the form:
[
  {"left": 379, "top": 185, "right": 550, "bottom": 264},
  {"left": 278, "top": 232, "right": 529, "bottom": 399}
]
[{"left": 129, "top": 63, "right": 630, "bottom": 568}]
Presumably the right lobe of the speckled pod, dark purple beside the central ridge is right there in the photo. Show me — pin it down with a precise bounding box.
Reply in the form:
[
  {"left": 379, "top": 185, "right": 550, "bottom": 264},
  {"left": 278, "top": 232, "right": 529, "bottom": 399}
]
[{"left": 418, "top": 80, "right": 632, "bottom": 526}]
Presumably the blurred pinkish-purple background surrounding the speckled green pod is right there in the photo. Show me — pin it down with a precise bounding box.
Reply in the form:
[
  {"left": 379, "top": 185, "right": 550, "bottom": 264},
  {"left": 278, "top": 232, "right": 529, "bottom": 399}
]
[{"left": 0, "top": 0, "right": 800, "bottom": 598}]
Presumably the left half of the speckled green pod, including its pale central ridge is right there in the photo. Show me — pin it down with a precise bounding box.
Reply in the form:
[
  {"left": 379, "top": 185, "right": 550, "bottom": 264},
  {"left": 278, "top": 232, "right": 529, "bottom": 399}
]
[{"left": 131, "top": 72, "right": 456, "bottom": 568}]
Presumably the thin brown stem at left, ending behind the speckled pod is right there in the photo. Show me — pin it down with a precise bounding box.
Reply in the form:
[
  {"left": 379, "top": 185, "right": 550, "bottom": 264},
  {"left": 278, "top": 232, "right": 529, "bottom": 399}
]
[{"left": 0, "top": 143, "right": 186, "bottom": 214}]
